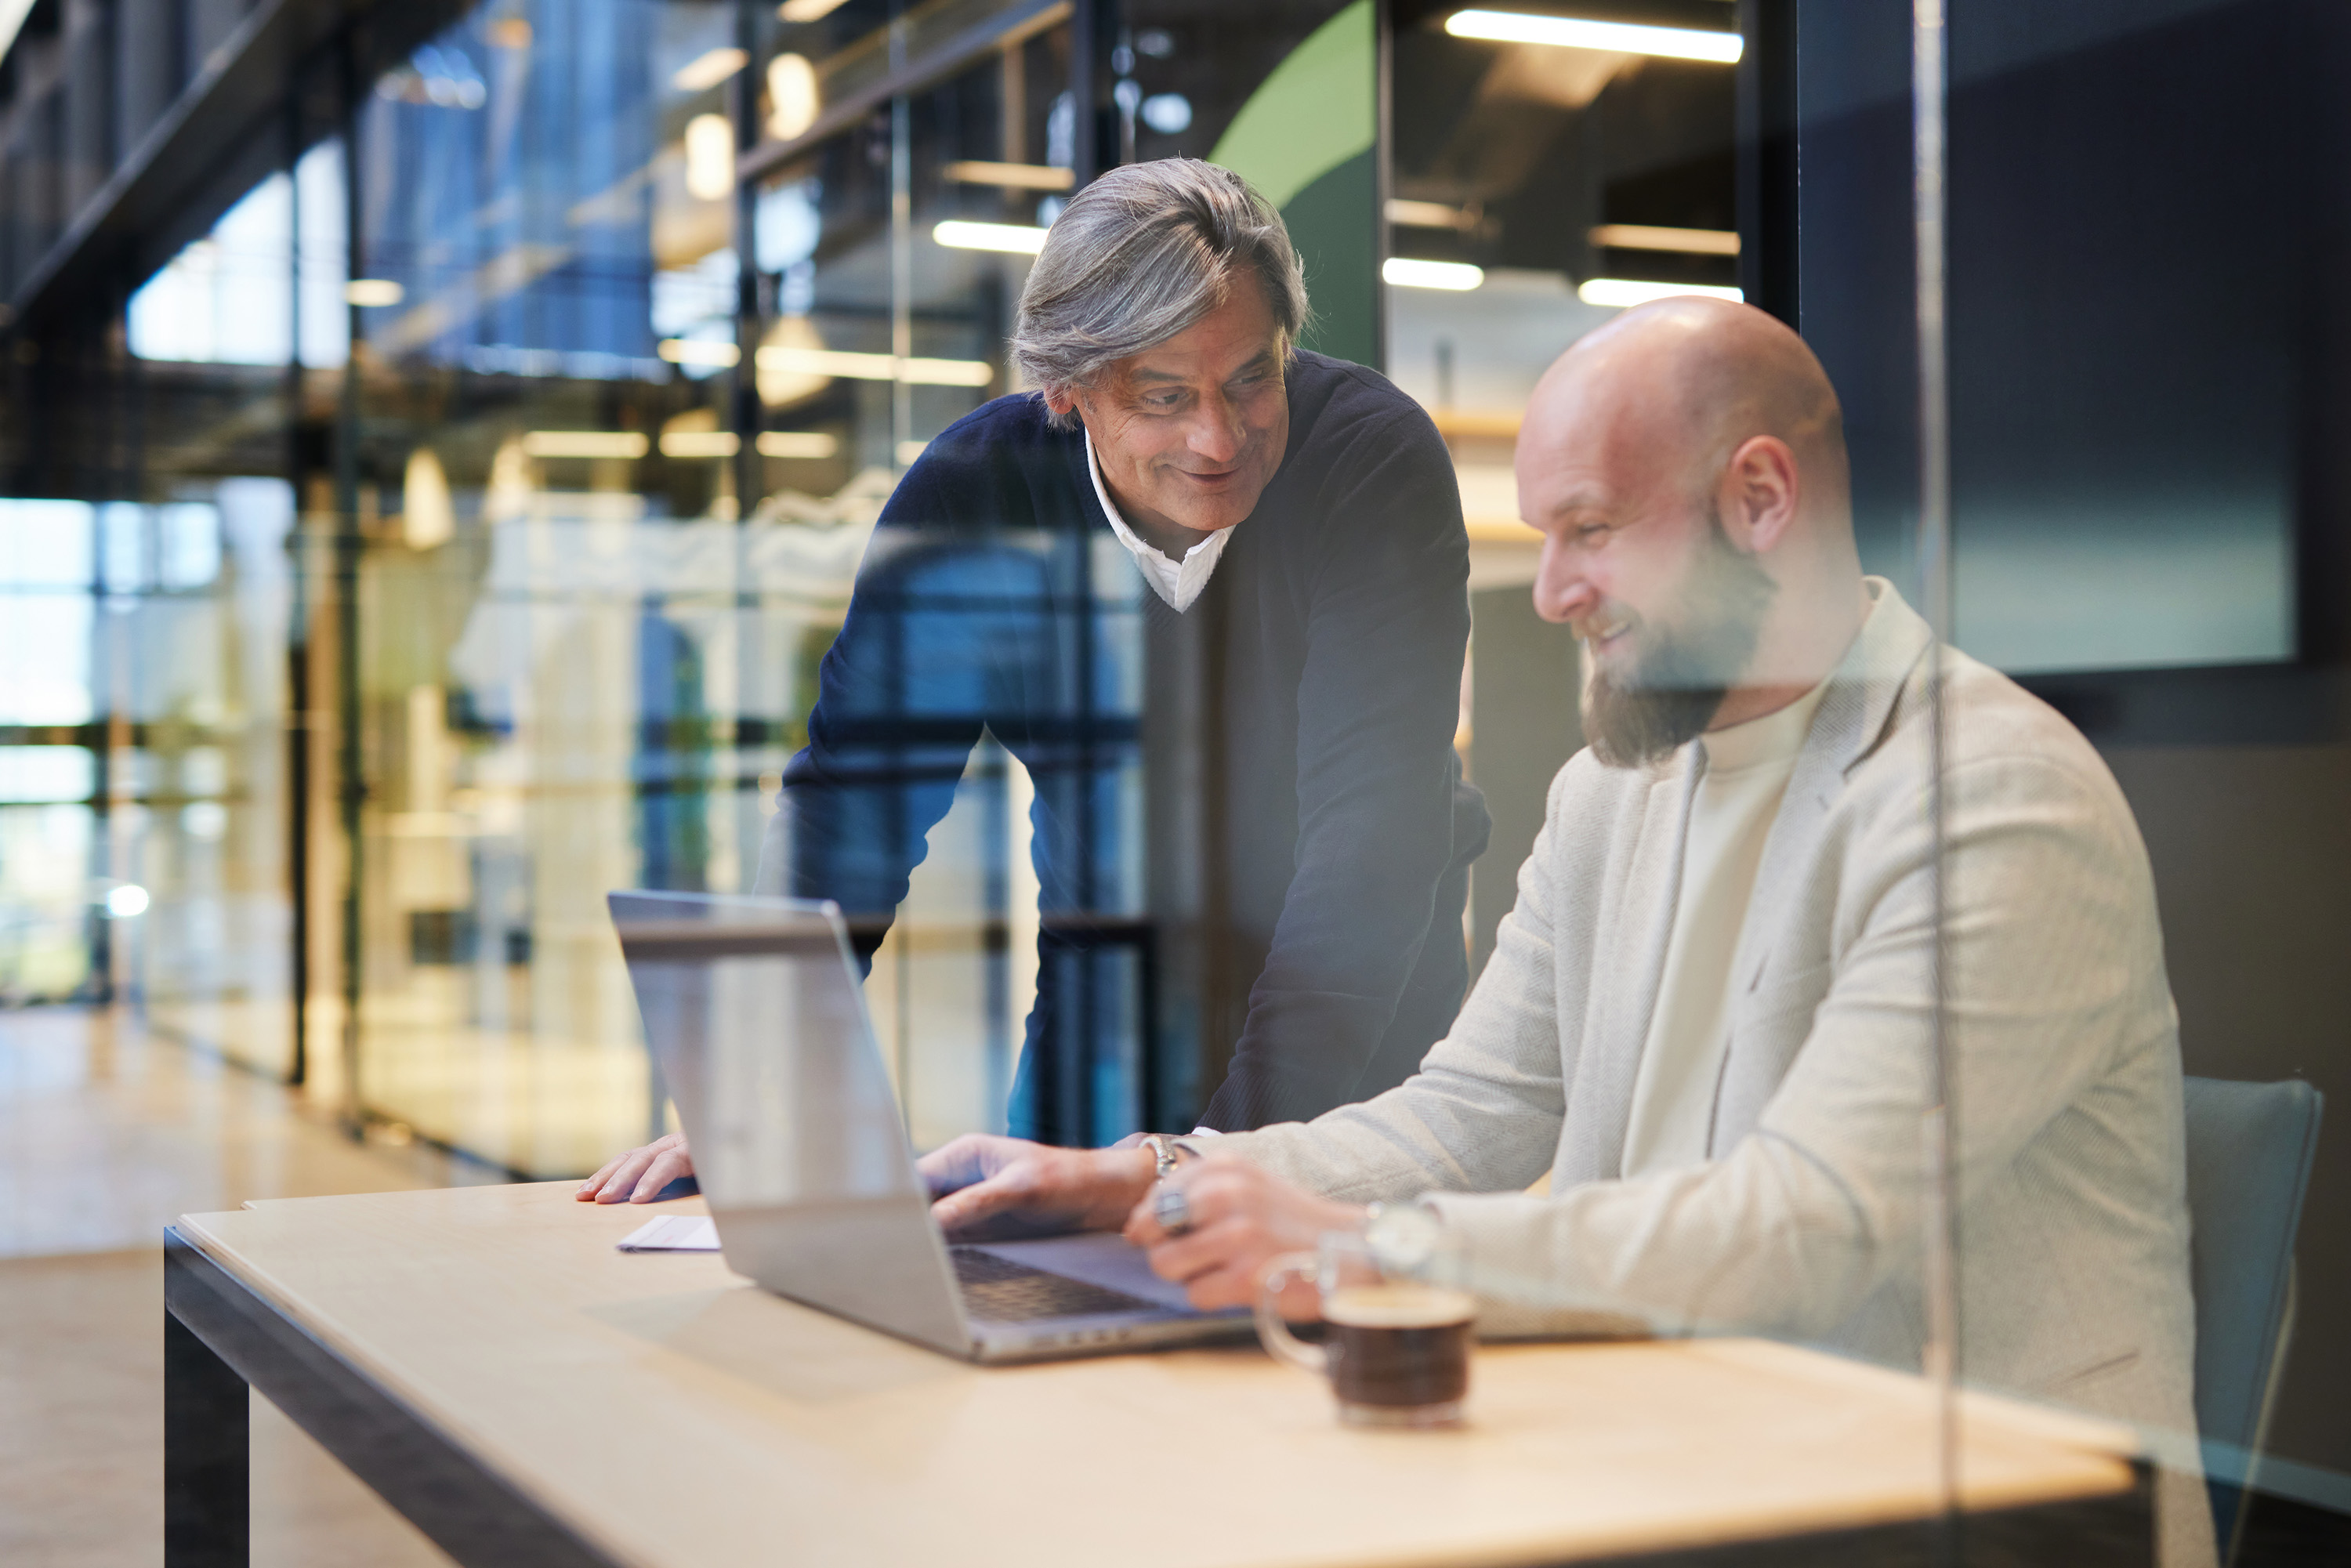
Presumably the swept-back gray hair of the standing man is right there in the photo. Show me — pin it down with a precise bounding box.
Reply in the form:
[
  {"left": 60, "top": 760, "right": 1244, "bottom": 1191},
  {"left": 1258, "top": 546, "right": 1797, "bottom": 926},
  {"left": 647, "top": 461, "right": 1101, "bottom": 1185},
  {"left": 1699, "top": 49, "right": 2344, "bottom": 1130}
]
[{"left": 1011, "top": 158, "right": 1310, "bottom": 425}]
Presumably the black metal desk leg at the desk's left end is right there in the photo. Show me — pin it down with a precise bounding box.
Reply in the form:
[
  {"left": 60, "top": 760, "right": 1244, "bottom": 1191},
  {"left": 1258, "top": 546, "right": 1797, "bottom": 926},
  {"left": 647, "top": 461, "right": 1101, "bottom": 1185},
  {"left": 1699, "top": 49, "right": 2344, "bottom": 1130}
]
[{"left": 162, "top": 1309, "right": 252, "bottom": 1568}]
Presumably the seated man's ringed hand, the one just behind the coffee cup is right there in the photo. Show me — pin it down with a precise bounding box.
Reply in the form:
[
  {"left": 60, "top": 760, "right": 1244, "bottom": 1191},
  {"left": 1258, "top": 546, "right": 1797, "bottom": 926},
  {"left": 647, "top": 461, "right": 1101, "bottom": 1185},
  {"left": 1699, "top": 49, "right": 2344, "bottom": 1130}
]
[{"left": 1126, "top": 1154, "right": 1364, "bottom": 1316}]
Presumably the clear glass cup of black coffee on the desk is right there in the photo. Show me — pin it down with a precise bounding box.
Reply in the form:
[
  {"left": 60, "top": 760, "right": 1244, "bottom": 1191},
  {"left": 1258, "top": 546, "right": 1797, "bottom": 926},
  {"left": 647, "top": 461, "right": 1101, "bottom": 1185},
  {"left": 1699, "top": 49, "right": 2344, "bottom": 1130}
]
[{"left": 1258, "top": 1229, "right": 1476, "bottom": 1427}]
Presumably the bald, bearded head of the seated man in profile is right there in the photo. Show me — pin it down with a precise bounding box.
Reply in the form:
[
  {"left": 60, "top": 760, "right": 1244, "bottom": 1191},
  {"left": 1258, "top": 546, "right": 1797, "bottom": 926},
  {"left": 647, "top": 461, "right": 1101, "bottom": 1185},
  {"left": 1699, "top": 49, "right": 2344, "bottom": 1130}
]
[{"left": 1516, "top": 296, "right": 1867, "bottom": 759}]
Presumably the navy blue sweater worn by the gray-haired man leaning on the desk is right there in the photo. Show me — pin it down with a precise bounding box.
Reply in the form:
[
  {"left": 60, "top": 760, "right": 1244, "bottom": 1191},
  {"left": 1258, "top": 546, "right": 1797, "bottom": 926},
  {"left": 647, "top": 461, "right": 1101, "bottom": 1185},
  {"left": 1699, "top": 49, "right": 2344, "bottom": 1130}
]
[{"left": 781, "top": 353, "right": 1488, "bottom": 1143}]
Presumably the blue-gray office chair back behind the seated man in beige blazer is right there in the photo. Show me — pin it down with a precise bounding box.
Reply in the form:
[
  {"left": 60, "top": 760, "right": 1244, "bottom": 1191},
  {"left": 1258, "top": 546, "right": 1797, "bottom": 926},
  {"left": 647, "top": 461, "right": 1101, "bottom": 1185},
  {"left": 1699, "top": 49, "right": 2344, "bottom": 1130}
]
[{"left": 2186, "top": 1079, "right": 2323, "bottom": 1563}]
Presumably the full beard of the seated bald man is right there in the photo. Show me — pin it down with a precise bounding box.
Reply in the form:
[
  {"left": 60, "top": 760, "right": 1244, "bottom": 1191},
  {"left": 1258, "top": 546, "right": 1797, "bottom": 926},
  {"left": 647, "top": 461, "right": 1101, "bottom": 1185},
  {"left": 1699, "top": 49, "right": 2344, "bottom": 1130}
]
[{"left": 1582, "top": 512, "right": 1777, "bottom": 769}]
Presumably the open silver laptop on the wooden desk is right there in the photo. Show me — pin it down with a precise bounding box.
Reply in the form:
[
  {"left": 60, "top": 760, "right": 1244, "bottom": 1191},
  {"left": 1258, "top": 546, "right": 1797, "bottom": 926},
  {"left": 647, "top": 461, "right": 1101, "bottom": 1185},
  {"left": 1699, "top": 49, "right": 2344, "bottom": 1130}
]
[{"left": 609, "top": 893, "right": 1248, "bottom": 1361}]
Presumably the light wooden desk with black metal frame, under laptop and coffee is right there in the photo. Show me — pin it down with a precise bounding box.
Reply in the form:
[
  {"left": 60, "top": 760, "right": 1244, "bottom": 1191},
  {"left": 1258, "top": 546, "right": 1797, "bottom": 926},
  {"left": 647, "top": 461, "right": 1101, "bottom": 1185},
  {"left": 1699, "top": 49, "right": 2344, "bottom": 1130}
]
[{"left": 165, "top": 1182, "right": 2154, "bottom": 1568}]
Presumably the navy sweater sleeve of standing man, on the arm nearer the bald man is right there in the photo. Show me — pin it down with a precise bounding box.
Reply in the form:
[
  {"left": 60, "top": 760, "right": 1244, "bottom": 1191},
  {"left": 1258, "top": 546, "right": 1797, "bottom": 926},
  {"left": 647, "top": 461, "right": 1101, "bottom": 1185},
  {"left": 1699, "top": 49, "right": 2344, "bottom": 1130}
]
[{"left": 1204, "top": 390, "right": 1469, "bottom": 1131}]
